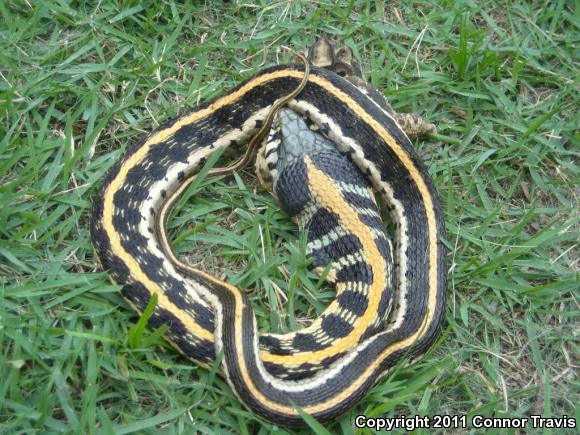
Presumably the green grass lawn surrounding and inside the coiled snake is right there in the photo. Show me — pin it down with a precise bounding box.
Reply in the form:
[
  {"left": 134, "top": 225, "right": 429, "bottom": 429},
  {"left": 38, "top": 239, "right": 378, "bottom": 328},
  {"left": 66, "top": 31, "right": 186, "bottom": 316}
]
[{"left": 0, "top": 0, "right": 580, "bottom": 434}]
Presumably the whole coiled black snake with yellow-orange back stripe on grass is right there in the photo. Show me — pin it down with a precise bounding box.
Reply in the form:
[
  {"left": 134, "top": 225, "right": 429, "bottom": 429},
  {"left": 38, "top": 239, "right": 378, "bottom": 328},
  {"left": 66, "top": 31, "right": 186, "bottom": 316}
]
[{"left": 91, "top": 39, "right": 446, "bottom": 426}]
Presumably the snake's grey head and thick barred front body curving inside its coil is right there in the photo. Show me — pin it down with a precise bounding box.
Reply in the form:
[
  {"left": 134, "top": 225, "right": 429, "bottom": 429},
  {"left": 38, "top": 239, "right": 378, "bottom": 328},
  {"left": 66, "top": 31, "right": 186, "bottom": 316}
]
[{"left": 258, "top": 109, "right": 394, "bottom": 379}]
